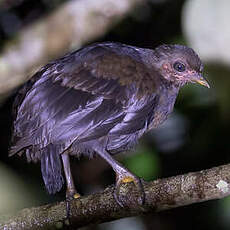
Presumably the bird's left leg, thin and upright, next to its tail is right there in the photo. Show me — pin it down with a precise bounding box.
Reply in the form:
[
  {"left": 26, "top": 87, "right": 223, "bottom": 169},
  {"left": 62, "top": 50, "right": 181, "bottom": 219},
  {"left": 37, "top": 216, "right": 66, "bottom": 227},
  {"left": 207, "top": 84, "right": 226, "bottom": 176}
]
[{"left": 61, "top": 152, "right": 80, "bottom": 218}]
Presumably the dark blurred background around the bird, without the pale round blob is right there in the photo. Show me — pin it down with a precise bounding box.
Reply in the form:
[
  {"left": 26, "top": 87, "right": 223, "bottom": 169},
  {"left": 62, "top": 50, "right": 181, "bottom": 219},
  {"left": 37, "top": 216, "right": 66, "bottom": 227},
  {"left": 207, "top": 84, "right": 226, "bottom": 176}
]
[{"left": 0, "top": 0, "right": 230, "bottom": 230}]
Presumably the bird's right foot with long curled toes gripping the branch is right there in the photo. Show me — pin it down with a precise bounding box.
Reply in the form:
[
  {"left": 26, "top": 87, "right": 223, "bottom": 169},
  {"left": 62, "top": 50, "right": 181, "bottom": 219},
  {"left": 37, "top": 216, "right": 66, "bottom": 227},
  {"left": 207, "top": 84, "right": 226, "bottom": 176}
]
[{"left": 114, "top": 170, "right": 145, "bottom": 208}]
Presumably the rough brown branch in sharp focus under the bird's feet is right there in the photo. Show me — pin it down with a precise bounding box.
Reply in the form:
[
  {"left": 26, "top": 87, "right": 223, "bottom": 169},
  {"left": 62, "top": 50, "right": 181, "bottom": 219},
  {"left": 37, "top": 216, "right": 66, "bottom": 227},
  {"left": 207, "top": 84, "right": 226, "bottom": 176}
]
[{"left": 0, "top": 164, "right": 230, "bottom": 230}]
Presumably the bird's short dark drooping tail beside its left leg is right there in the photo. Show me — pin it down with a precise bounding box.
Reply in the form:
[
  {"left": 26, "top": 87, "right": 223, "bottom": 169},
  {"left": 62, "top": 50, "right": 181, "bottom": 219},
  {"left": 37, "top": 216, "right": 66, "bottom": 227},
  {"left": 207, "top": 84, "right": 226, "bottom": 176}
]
[{"left": 41, "top": 144, "right": 64, "bottom": 194}]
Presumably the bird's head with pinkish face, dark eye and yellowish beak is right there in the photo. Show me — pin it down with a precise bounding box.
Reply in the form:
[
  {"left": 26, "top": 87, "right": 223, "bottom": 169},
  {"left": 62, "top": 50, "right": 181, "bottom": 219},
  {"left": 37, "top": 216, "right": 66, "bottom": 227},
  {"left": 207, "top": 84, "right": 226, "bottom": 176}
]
[{"left": 155, "top": 45, "right": 209, "bottom": 88}]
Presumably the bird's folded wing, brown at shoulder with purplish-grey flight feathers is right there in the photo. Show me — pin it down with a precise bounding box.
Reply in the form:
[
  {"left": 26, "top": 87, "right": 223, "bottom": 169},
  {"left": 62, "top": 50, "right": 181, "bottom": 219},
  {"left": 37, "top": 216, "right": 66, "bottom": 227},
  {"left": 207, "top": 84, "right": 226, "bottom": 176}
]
[{"left": 11, "top": 44, "right": 158, "bottom": 154}]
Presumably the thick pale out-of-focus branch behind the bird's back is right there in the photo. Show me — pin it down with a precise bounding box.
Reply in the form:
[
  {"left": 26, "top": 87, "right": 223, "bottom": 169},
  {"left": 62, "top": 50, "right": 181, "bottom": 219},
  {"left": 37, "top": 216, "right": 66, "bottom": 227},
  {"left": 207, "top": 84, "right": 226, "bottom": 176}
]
[{"left": 0, "top": 0, "right": 144, "bottom": 101}]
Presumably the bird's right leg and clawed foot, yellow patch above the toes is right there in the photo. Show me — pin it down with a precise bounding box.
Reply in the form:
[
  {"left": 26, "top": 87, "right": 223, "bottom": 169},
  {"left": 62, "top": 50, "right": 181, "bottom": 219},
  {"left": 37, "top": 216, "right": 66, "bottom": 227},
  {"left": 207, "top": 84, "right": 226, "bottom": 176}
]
[{"left": 97, "top": 150, "right": 145, "bottom": 207}]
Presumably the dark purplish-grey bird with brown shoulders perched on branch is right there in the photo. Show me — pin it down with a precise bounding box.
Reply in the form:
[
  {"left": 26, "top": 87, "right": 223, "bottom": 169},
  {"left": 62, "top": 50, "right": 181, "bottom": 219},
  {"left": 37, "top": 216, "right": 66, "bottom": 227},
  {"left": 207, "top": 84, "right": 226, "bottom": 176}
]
[{"left": 10, "top": 42, "right": 209, "bottom": 207}]
